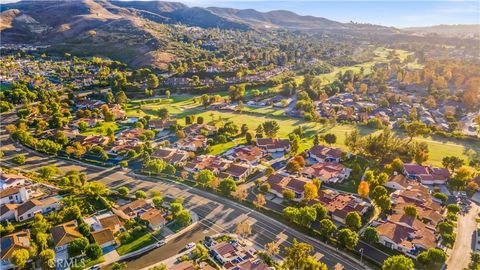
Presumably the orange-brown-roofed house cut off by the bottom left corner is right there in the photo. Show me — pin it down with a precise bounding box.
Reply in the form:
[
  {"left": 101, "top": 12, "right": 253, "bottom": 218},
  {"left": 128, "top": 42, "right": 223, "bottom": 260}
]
[{"left": 0, "top": 230, "right": 31, "bottom": 269}]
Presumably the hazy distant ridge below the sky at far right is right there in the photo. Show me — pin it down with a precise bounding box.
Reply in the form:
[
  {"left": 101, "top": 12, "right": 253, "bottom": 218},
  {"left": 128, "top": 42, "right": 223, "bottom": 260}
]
[{"left": 403, "top": 24, "right": 480, "bottom": 38}]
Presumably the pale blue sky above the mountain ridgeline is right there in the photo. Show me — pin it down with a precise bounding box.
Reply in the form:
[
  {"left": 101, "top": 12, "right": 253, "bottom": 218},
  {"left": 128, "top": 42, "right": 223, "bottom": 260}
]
[{"left": 182, "top": 0, "right": 480, "bottom": 27}]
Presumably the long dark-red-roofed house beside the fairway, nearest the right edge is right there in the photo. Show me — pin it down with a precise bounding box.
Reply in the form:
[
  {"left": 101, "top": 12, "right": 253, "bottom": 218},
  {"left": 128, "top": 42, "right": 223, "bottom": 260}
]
[{"left": 403, "top": 163, "right": 450, "bottom": 185}]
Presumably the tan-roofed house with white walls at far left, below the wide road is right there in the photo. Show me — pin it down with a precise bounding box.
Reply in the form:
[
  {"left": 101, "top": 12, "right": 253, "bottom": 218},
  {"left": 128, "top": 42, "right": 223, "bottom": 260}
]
[{"left": 15, "top": 196, "right": 60, "bottom": 221}]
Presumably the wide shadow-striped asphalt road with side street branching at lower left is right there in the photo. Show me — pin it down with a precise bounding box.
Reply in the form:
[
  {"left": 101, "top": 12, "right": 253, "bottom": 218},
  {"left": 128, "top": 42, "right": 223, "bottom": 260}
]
[{"left": 0, "top": 111, "right": 365, "bottom": 269}]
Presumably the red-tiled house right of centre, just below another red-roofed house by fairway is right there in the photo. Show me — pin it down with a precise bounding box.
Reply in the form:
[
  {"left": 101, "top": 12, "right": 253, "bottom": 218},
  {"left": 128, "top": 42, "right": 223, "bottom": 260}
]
[{"left": 301, "top": 162, "right": 352, "bottom": 183}]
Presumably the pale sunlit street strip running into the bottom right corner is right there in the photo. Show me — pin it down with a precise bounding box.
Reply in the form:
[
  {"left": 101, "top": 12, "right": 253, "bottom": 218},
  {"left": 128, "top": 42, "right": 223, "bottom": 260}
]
[{"left": 447, "top": 202, "right": 480, "bottom": 270}]
